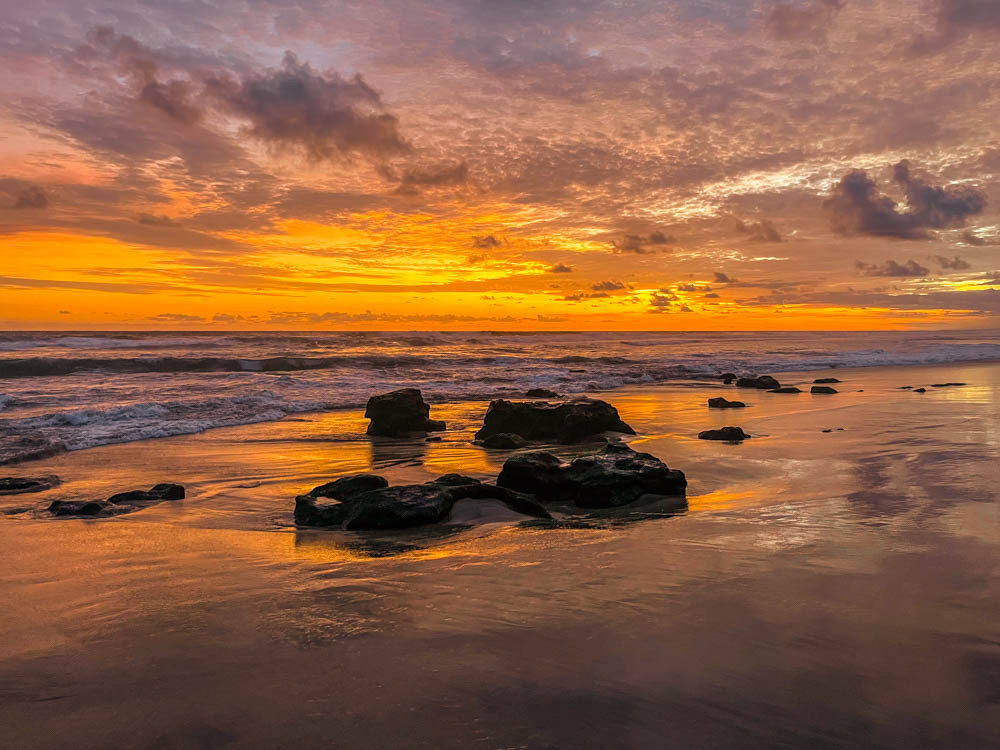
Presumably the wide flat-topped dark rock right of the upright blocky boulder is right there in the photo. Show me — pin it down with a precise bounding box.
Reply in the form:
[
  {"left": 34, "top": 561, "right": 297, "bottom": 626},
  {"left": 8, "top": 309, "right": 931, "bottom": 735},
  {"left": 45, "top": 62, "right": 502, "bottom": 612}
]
[{"left": 476, "top": 398, "right": 635, "bottom": 443}]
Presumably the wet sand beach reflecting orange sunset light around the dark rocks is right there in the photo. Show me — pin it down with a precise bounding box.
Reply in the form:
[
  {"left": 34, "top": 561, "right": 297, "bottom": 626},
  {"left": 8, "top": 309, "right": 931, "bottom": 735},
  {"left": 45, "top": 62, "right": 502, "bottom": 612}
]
[{"left": 0, "top": 364, "right": 1000, "bottom": 748}]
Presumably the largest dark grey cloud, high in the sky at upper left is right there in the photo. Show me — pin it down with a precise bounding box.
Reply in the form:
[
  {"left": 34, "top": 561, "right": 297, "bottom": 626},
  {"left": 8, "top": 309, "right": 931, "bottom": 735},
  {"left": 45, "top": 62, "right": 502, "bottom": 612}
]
[{"left": 205, "top": 52, "right": 408, "bottom": 159}]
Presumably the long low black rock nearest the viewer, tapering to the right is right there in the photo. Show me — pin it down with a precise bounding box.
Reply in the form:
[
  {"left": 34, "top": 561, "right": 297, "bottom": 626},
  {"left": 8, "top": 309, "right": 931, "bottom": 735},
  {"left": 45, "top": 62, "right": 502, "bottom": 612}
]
[{"left": 295, "top": 474, "right": 550, "bottom": 530}]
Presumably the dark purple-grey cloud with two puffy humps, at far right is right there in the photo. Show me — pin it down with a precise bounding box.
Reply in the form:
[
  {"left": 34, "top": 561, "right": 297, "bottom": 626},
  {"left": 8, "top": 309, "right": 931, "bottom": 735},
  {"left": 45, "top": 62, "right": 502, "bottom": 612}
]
[{"left": 823, "top": 160, "right": 986, "bottom": 240}]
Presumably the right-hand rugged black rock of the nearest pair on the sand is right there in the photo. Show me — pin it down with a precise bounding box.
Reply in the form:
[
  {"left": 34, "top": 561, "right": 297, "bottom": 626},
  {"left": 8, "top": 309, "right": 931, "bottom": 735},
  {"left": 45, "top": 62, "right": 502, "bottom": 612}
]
[{"left": 497, "top": 443, "right": 687, "bottom": 508}]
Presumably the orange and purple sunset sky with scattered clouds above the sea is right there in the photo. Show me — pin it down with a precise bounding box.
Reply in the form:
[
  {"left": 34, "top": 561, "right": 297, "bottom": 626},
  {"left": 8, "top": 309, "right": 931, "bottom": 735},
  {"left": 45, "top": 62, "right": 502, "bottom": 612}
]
[{"left": 0, "top": 0, "right": 1000, "bottom": 330}]
